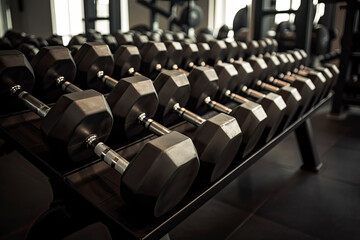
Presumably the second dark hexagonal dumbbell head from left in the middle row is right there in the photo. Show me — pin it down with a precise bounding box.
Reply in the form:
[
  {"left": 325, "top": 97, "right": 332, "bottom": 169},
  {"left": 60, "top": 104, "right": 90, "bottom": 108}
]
[{"left": 107, "top": 76, "right": 158, "bottom": 137}]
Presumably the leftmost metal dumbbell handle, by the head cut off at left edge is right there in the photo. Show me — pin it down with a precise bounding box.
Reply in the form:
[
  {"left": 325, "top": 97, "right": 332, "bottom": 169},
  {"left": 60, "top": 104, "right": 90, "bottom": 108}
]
[{"left": 10, "top": 85, "right": 50, "bottom": 118}]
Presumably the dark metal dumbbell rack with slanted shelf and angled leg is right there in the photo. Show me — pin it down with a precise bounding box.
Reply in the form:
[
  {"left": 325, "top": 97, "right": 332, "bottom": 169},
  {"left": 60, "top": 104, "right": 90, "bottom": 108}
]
[{"left": 0, "top": 93, "right": 333, "bottom": 239}]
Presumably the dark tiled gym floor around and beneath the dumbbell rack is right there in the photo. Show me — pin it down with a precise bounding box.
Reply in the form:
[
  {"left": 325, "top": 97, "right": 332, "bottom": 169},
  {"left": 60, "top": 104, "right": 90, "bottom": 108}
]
[{"left": 0, "top": 102, "right": 360, "bottom": 240}]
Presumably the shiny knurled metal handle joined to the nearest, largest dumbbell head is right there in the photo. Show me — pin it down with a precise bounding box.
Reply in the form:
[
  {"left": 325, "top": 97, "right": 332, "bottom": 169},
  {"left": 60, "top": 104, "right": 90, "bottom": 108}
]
[{"left": 86, "top": 135, "right": 129, "bottom": 175}]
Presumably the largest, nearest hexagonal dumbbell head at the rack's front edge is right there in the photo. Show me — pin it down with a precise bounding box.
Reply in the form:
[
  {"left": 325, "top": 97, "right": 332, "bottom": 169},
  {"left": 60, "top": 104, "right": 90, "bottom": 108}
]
[{"left": 120, "top": 132, "right": 199, "bottom": 217}]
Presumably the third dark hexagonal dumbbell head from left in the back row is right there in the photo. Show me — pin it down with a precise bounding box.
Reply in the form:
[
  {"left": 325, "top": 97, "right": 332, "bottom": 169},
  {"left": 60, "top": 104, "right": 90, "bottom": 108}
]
[{"left": 74, "top": 42, "right": 114, "bottom": 92}]
